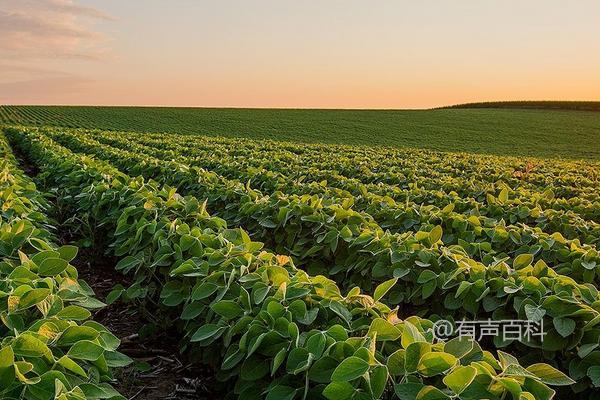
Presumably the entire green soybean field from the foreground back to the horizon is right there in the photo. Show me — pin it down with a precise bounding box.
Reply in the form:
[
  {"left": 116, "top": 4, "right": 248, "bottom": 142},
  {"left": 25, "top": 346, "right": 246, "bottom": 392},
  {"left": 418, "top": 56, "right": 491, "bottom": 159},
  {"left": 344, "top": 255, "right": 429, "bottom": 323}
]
[{"left": 0, "top": 110, "right": 600, "bottom": 400}]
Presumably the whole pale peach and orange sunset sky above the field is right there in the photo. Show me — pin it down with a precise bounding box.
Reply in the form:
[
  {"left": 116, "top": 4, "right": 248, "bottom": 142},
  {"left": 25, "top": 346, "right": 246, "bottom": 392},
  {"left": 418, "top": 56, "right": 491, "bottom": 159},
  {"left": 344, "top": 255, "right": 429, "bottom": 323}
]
[{"left": 0, "top": 0, "right": 600, "bottom": 108}]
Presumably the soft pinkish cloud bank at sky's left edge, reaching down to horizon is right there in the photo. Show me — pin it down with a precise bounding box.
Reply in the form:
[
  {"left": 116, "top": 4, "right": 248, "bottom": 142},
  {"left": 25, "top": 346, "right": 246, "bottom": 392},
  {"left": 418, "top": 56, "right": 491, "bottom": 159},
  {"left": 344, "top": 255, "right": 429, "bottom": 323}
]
[{"left": 0, "top": 0, "right": 114, "bottom": 104}]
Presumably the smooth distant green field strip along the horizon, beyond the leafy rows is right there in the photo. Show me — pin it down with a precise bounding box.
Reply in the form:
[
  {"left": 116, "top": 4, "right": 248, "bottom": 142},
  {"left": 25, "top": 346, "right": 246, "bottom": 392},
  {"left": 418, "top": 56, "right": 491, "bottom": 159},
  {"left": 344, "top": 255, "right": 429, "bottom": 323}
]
[{"left": 0, "top": 106, "right": 600, "bottom": 160}]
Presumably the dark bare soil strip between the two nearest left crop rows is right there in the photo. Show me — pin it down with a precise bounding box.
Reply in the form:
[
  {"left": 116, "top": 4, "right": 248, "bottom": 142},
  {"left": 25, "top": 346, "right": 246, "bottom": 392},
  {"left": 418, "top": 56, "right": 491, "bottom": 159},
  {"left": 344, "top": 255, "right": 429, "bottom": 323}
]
[{"left": 12, "top": 141, "right": 224, "bottom": 400}]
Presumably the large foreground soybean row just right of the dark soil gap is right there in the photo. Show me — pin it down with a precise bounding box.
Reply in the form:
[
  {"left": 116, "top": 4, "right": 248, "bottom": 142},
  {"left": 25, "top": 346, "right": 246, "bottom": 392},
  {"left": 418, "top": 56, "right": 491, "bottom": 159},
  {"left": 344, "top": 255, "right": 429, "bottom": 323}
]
[{"left": 3, "top": 126, "right": 572, "bottom": 399}]
